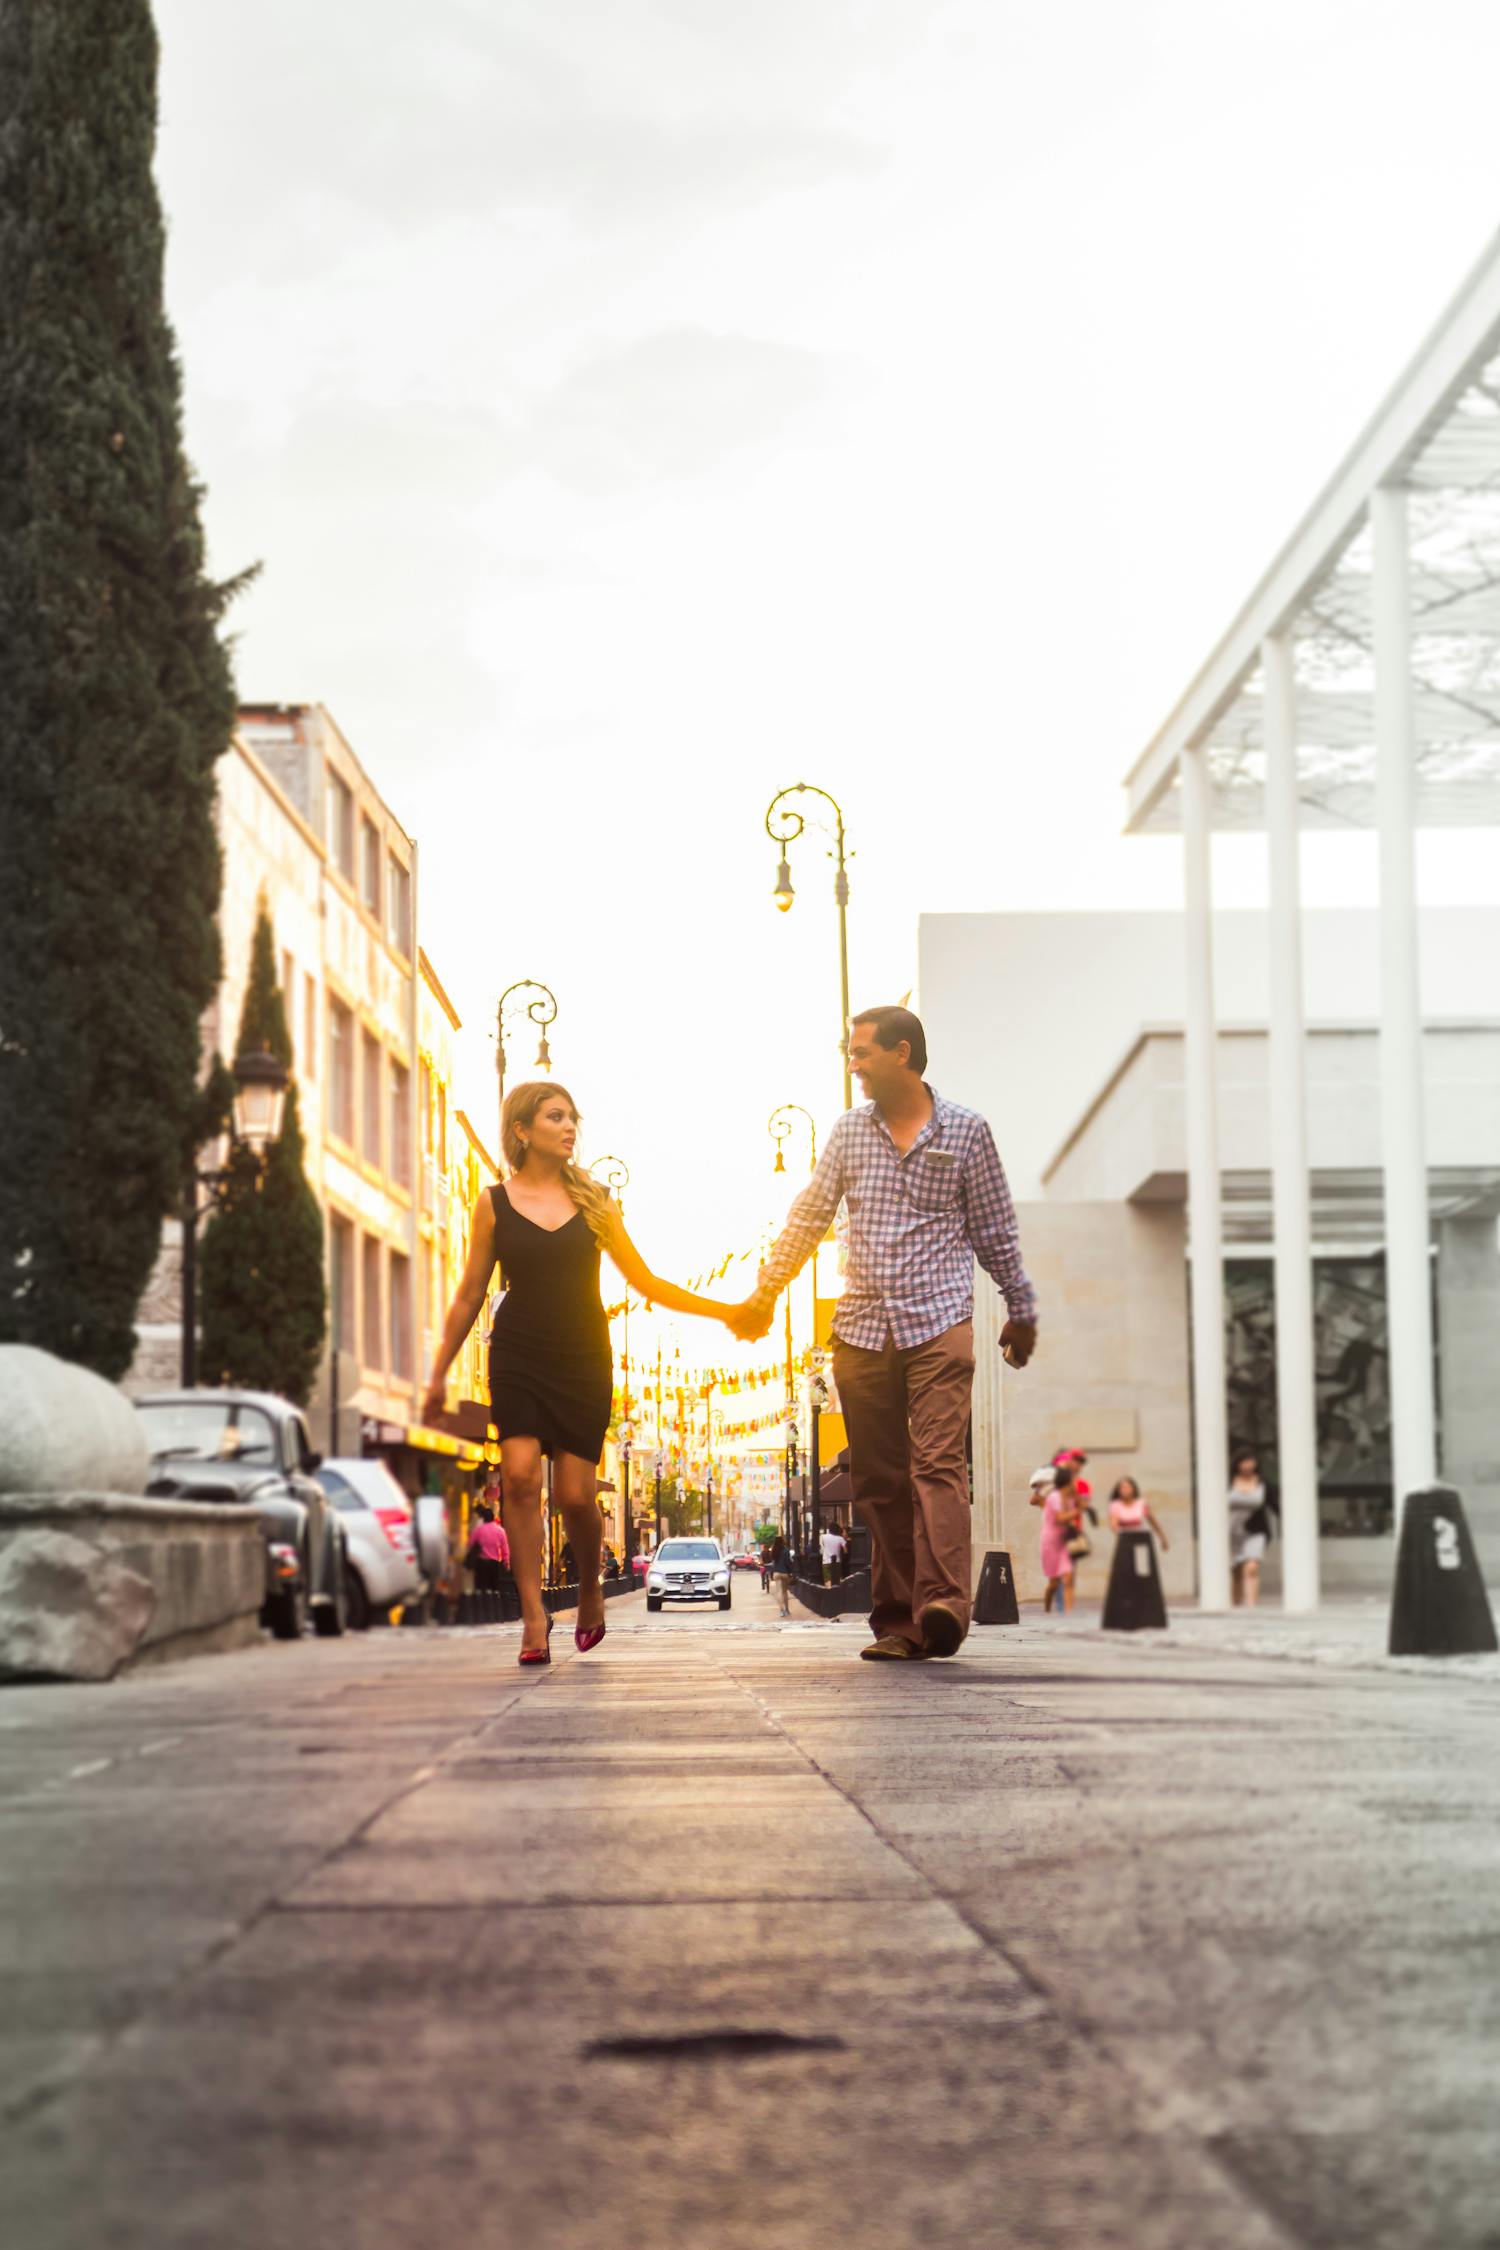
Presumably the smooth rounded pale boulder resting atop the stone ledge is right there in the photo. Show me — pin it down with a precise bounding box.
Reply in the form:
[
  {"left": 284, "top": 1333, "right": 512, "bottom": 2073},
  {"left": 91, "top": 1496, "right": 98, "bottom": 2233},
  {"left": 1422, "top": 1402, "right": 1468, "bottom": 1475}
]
[{"left": 0, "top": 1343, "right": 148, "bottom": 1494}]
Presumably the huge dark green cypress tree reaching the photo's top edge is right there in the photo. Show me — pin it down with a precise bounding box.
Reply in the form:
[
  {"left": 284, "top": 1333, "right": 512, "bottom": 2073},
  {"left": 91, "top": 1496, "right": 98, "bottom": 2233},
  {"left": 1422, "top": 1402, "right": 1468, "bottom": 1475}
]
[{"left": 0, "top": 0, "right": 251, "bottom": 1375}]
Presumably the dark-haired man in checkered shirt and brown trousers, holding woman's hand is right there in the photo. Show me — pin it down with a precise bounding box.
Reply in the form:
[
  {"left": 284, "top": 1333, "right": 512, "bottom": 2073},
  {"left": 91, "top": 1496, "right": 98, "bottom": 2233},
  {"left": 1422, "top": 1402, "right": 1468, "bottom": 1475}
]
[{"left": 733, "top": 1008, "right": 1037, "bottom": 1661}]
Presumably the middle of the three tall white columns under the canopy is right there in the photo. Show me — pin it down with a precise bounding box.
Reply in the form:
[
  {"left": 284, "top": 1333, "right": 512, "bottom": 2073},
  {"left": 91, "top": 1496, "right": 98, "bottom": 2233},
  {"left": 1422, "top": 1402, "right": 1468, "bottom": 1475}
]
[{"left": 1262, "top": 637, "right": 1318, "bottom": 1609}]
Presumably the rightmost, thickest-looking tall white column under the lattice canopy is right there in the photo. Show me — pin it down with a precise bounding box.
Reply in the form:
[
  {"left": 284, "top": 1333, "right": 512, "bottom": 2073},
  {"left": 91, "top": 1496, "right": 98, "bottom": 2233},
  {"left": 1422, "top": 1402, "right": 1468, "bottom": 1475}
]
[{"left": 1370, "top": 486, "right": 1437, "bottom": 1523}]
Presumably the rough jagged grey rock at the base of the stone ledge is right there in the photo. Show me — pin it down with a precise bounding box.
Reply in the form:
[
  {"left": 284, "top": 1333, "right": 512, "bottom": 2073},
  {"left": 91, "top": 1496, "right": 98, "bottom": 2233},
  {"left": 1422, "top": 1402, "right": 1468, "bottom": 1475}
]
[{"left": 0, "top": 1530, "right": 155, "bottom": 1681}]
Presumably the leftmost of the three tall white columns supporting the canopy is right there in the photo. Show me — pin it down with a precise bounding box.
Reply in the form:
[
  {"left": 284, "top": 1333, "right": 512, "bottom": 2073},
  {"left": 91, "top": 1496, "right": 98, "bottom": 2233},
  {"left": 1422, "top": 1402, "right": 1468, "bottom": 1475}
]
[{"left": 1183, "top": 749, "right": 1230, "bottom": 1609}]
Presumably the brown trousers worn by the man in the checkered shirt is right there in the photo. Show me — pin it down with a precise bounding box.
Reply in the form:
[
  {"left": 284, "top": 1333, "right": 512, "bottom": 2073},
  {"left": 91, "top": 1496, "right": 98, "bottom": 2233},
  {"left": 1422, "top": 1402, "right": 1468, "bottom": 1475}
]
[{"left": 834, "top": 1321, "right": 974, "bottom": 1645}]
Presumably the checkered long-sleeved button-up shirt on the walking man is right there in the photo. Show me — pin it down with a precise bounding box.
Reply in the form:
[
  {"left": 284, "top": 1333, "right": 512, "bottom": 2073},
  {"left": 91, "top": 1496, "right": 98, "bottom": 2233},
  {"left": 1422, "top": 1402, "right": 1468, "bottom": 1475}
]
[{"left": 758, "top": 1087, "right": 1037, "bottom": 1352}]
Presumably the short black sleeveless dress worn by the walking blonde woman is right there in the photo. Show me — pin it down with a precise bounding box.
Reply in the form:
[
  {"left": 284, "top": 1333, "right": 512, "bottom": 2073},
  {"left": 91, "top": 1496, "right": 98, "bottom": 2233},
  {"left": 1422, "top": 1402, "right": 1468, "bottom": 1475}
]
[{"left": 490, "top": 1186, "right": 614, "bottom": 1460}]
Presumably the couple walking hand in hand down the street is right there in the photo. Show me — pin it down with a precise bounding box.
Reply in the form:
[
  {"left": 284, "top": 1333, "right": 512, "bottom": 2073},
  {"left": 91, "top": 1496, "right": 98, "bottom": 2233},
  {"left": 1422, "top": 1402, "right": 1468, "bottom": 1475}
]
[{"left": 423, "top": 1008, "right": 1037, "bottom": 1665}]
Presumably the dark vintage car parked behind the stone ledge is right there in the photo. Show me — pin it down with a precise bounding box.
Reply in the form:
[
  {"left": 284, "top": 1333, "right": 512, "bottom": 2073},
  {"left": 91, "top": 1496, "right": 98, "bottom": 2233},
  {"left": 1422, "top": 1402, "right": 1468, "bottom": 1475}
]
[{"left": 135, "top": 1391, "right": 349, "bottom": 1640}]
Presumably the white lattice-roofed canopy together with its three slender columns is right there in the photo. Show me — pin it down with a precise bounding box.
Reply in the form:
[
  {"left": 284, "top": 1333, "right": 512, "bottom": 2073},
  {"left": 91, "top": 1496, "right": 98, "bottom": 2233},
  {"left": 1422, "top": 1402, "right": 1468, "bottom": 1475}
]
[{"left": 1127, "top": 223, "right": 1500, "bottom": 1609}]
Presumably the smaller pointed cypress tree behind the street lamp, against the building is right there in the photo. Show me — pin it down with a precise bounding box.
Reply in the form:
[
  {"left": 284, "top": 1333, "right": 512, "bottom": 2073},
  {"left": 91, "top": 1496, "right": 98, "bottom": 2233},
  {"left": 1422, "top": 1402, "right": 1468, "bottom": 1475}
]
[{"left": 198, "top": 902, "right": 326, "bottom": 1406}]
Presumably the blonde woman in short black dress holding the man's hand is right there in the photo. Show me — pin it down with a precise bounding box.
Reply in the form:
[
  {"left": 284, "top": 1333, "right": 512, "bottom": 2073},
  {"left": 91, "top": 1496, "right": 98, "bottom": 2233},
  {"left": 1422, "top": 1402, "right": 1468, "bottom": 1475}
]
[{"left": 423, "top": 1080, "right": 735, "bottom": 1665}]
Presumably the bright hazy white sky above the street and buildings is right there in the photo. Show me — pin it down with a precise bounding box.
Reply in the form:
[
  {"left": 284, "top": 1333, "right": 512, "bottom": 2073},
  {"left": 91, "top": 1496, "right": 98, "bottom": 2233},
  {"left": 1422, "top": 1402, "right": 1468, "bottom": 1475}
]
[{"left": 157, "top": 0, "right": 1500, "bottom": 1339}]
